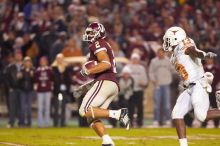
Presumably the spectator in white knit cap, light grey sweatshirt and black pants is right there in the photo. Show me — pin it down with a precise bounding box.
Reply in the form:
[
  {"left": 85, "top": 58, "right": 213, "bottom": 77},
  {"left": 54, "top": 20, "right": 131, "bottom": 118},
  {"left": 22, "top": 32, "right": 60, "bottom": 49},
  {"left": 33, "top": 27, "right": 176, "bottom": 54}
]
[{"left": 123, "top": 53, "right": 148, "bottom": 127}]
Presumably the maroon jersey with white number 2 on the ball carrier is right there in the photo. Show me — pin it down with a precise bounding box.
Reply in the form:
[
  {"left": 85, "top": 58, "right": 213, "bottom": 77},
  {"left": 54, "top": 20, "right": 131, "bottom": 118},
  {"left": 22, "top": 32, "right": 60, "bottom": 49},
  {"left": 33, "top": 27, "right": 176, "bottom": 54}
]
[{"left": 89, "top": 39, "right": 118, "bottom": 84}]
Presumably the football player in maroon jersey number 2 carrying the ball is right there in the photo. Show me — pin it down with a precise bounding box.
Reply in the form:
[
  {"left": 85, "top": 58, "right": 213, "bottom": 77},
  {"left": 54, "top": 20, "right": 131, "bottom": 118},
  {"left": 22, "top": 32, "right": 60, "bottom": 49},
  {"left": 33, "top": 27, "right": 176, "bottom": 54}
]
[{"left": 79, "top": 22, "right": 130, "bottom": 146}]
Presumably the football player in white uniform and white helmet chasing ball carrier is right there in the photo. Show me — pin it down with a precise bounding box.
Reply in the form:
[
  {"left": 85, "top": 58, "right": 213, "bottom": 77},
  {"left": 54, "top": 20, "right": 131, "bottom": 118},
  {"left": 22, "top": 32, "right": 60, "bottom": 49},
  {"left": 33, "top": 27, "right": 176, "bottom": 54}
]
[{"left": 163, "top": 27, "right": 220, "bottom": 146}]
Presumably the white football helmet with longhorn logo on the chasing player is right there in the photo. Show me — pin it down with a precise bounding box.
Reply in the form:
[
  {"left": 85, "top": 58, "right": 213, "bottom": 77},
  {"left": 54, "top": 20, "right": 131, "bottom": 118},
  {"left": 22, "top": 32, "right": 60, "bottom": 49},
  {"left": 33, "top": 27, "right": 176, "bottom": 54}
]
[{"left": 163, "top": 26, "right": 186, "bottom": 51}]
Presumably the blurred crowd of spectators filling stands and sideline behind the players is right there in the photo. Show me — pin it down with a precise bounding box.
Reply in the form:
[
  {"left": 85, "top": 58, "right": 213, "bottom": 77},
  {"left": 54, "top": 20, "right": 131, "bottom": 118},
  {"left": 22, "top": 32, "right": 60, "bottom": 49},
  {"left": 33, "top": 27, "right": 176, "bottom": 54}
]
[{"left": 0, "top": 0, "right": 220, "bottom": 127}]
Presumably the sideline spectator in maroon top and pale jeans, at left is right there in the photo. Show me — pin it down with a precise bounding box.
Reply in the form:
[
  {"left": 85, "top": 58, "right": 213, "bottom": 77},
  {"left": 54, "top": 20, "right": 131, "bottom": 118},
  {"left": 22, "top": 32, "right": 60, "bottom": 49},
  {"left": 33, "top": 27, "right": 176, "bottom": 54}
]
[{"left": 34, "top": 56, "right": 53, "bottom": 127}]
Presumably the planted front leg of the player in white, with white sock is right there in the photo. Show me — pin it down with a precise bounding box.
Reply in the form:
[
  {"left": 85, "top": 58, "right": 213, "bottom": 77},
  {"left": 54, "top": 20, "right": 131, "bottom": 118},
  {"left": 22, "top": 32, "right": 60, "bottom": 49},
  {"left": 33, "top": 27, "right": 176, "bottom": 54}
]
[{"left": 172, "top": 90, "right": 192, "bottom": 146}]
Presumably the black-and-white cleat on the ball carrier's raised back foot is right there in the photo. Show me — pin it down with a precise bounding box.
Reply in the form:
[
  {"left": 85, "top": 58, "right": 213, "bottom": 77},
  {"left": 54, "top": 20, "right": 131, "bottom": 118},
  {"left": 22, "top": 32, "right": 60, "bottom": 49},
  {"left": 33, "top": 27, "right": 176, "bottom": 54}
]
[{"left": 119, "top": 108, "right": 130, "bottom": 130}]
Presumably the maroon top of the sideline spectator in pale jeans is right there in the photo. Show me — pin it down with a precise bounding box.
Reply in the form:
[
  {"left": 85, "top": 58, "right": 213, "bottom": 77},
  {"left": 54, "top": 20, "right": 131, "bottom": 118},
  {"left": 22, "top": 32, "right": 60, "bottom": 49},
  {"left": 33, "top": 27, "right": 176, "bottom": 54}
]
[{"left": 34, "top": 67, "right": 53, "bottom": 92}]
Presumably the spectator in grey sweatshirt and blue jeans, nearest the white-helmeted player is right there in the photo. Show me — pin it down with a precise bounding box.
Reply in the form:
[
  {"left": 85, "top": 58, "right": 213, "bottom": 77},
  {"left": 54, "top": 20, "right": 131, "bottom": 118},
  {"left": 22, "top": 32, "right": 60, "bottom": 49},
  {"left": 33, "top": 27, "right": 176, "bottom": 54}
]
[{"left": 149, "top": 49, "right": 172, "bottom": 127}]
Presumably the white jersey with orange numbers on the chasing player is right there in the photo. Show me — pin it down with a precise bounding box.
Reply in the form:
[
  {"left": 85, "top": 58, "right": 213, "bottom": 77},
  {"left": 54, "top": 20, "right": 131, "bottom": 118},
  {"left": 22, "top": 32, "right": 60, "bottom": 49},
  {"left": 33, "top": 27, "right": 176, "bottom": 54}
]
[{"left": 171, "top": 38, "right": 204, "bottom": 85}]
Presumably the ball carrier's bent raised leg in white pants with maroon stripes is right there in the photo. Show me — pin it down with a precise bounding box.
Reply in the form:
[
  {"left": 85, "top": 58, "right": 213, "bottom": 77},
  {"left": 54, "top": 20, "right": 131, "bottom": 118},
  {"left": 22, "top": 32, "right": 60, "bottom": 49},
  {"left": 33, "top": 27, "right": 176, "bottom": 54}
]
[{"left": 79, "top": 81, "right": 128, "bottom": 126}]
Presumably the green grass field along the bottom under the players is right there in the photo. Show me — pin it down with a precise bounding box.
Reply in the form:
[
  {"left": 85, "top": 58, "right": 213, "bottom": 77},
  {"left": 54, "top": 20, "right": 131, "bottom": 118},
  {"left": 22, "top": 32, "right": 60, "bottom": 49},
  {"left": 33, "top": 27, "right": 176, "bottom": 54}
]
[{"left": 0, "top": 128, "right": 220, "bottom": 146}]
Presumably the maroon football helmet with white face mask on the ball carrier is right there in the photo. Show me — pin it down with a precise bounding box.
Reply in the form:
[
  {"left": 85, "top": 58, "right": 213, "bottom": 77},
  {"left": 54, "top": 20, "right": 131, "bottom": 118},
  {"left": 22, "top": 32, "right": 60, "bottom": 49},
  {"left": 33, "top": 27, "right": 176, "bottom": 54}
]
[{"left": 83, "top": 22, "right": 105, "bottom": 42}]
